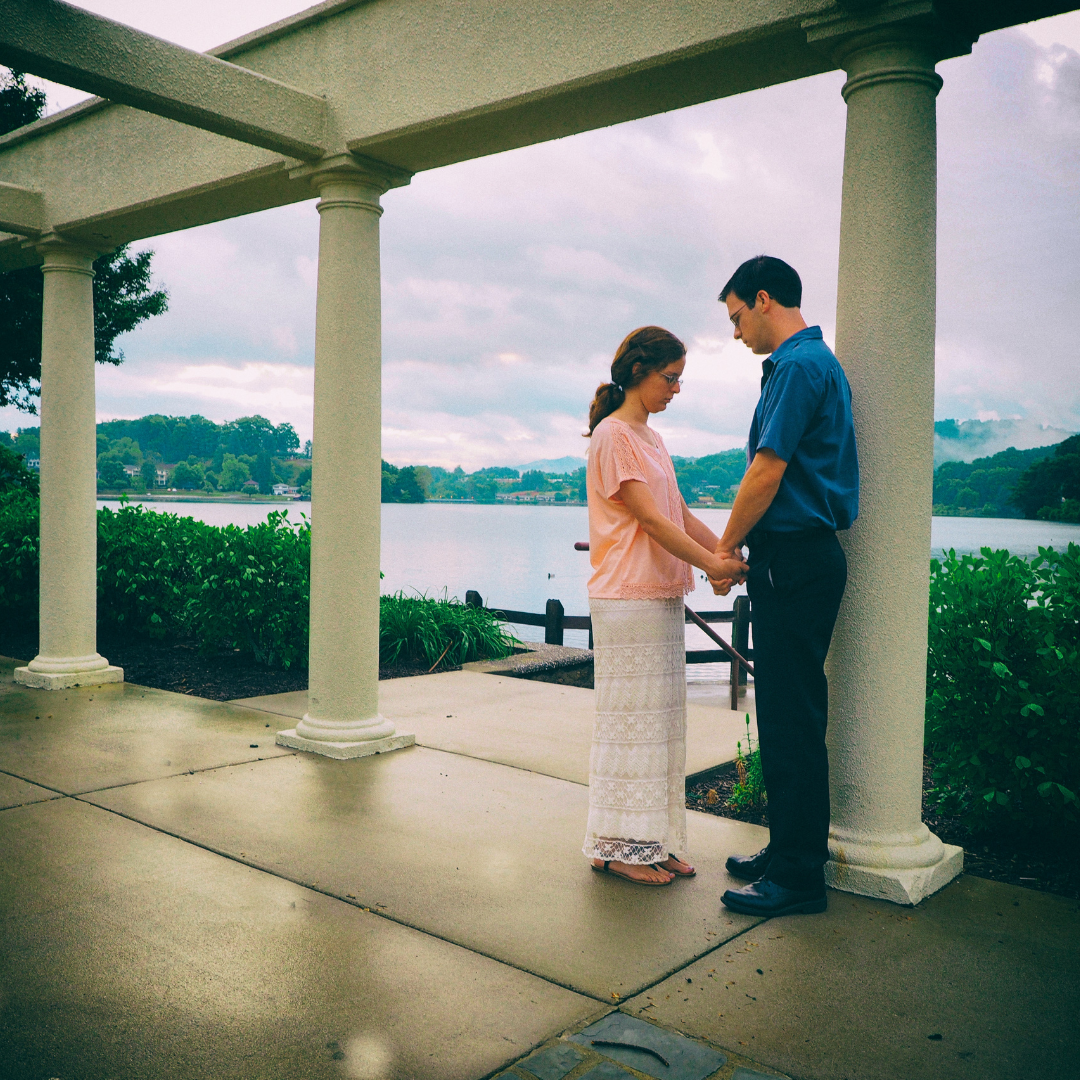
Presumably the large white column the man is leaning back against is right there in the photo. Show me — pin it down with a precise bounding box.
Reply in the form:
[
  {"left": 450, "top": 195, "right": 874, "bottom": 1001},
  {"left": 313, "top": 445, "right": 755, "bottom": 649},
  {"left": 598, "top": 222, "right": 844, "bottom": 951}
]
[{"left": 826, "top": 39, "right": 963, "bottom": 904}]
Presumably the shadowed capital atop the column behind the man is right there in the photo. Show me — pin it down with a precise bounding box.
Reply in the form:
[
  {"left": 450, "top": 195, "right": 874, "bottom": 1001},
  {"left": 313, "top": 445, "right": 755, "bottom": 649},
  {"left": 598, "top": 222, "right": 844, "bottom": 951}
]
[{"left": 801, "top": 0, "right": 978, "bottom": 70}]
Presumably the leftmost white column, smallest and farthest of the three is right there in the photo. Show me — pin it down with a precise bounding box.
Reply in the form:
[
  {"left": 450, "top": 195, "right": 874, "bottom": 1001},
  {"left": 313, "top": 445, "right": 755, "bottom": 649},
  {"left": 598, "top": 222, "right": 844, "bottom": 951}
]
[{"left": 15, "top": 238, "right": 124, "bottom": 690}]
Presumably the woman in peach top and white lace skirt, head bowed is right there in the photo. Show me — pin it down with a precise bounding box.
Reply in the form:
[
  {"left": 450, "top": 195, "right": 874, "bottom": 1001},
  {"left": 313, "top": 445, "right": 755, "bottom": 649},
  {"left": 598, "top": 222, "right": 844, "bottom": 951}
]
[{"left": 582, "top": 326, "right": 746, "bottom": 886}]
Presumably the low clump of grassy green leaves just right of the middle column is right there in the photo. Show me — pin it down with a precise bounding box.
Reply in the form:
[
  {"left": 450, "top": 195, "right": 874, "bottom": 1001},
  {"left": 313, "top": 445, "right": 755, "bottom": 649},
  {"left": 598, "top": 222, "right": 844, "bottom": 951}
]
[{"left": 379, "top": 592, "right": 517, "bottom": 667}]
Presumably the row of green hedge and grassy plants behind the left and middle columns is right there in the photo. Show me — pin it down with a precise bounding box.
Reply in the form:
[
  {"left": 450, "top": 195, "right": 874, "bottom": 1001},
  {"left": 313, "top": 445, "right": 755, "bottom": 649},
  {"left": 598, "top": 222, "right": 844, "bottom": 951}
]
[{"left": 0, "top": 491, "right": 514, "bottom": 667}]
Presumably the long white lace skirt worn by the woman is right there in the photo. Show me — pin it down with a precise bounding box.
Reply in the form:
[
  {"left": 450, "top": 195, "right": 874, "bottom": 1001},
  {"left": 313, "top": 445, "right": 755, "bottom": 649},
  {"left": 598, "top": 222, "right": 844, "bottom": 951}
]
[{"left": 582, "top": 596, "right": 686, "bottom": 865}]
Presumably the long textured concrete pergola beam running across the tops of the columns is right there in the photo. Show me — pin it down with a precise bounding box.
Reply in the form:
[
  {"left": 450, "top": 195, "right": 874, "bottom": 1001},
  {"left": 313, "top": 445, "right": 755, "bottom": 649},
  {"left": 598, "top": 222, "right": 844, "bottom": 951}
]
[{"left": 0, "top": 0, "right": 1077, "bottom": 272}]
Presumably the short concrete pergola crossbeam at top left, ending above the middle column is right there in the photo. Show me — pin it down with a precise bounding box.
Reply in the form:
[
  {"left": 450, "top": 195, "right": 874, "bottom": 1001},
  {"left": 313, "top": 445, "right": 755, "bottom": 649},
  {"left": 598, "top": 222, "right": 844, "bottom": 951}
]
[{"left": 0, "top": 0, "right": 327, "bottom": 159}]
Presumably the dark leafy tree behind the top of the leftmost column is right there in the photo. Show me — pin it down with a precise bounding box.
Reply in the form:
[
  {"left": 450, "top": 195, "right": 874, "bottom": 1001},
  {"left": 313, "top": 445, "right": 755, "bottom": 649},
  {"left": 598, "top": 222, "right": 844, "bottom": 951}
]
[{"left": 0, "top": 71, "right": 168, "bottom": 413}]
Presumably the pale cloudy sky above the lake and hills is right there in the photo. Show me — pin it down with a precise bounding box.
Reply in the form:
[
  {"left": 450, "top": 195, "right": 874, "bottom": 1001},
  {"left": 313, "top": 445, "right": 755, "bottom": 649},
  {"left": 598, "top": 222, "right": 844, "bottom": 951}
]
[{"left": 0, "top": 0, "right": 1080, "bottom": 471}]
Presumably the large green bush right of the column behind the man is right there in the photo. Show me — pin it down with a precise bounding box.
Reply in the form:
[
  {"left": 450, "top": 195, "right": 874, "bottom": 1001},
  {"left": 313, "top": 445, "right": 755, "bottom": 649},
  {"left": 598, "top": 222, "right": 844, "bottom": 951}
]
[{"left": 927, "top": 543, "right": 1080, "bottom": 832}]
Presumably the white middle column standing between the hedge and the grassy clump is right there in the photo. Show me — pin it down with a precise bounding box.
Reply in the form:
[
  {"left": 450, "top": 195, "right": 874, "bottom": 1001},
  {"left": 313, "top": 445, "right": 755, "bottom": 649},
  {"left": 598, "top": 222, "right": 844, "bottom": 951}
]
[{"left": 278, "top": 154, "right": 416, "bottom": 758}]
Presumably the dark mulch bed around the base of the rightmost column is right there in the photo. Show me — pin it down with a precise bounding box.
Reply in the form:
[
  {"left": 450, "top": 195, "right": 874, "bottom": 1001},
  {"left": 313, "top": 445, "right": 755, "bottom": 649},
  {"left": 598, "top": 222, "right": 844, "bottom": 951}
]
[{"left": 686, "top": 758, "right": 1080, "bottom": 900}]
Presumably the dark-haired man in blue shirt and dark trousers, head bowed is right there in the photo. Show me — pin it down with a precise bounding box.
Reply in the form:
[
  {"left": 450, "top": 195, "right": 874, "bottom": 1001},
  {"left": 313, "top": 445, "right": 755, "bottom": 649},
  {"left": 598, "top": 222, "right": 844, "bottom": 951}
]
[{"left": 717, "top": 255, "right": 859, "bottom": 916}]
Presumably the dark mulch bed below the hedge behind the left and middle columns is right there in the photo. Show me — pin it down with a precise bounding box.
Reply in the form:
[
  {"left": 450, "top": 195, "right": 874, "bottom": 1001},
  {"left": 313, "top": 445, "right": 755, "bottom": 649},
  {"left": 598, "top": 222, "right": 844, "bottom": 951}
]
[{"left": 0, "top": 631, "right": 460, "bottom": 701}]
